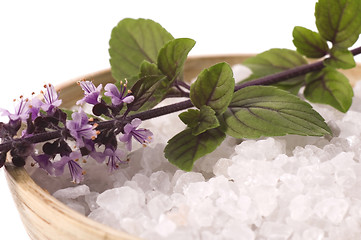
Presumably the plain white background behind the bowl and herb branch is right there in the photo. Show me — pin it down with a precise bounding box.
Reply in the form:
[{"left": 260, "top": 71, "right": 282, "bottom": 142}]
[{"left": 0, "top": 0, "right": 361, "bottom": 240}]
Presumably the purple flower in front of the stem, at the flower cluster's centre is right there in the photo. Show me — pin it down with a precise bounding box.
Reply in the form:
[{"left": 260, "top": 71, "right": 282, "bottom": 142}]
[{"left": 66, "top": 109, "right": 97, "bottom": 147}]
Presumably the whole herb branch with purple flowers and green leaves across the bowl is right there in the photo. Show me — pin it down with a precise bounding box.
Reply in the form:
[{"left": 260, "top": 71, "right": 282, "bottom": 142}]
[{"left": 0, "top": 0, "right": 361, "bottom": 180}]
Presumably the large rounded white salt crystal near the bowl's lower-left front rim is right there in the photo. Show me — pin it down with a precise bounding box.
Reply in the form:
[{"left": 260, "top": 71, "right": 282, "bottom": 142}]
[{"left": 97, "top": 186, "right": 145, "bottom": 218}]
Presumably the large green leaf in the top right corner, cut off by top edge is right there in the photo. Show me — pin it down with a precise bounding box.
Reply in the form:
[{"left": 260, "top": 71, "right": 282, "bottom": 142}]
[{"left": 315, "top": 0, "right": 361, "bottom": 48}]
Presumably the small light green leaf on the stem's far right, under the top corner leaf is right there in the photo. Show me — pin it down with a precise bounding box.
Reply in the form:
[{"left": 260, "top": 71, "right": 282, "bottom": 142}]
[{"left": 324, "top": 48, "right": 356, "bottom": 69}]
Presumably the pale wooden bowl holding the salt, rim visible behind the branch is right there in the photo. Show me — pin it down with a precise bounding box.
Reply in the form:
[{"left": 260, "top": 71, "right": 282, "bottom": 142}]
[{"left": 5, "top": 55, "right": 361, "bottom": 240}]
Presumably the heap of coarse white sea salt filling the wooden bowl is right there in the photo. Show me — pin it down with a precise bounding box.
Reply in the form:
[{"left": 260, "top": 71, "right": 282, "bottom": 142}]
[{"left": 29, "top": 66, "right": 361, "bottom": 240}]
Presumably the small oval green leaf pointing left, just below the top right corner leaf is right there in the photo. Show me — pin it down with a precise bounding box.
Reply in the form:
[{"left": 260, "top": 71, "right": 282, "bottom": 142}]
[{"left": 292, "top": 27, "right": 329, "bottom": 58}]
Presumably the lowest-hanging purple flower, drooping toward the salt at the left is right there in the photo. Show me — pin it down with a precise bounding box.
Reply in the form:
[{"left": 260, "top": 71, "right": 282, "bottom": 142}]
[{"left": 53, "top": 152, "right": 84, "bottom": 183}]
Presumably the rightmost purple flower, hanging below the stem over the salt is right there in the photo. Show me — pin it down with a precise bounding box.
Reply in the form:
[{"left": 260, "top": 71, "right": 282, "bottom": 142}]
[{"left": 119, "top": 118, "right": 153, "bottom": 151}]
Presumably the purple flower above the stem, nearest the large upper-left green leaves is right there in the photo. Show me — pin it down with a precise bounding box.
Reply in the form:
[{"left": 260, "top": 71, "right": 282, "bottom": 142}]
[{"left": 104, "top": 82, "right": 134, "bottom": 106}]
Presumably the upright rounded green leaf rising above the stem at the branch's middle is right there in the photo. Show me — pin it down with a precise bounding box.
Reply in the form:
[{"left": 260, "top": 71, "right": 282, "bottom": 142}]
[{"left": 190, "top": 63, "right": 234, "bottom": 114}]
